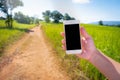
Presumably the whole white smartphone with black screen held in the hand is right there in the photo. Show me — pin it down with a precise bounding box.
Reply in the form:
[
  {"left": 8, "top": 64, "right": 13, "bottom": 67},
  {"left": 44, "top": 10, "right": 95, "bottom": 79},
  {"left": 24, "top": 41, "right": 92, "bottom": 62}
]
[{"left": 63, "top": 20, "right": 82, "bottom": 54}]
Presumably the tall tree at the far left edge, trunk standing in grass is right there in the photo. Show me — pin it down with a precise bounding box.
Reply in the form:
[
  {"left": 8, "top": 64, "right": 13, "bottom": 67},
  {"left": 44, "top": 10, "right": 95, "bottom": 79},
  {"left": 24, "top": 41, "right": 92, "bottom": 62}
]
[{"left": 0, "top": 0, "right": 23, "bottom": 28}]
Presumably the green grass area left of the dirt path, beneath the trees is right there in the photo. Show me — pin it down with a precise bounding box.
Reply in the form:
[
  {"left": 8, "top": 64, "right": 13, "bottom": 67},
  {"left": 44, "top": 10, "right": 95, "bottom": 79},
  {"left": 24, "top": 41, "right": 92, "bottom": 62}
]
[{"left": 0, "top": 20, "right": 35, "bottom": 55}]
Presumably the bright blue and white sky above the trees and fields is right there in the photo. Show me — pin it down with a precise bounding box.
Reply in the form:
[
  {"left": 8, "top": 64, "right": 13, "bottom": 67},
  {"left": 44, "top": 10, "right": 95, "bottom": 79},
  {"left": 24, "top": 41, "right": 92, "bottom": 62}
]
[{"left": 0, "top": 0, "right": 120, "bottom": 23}]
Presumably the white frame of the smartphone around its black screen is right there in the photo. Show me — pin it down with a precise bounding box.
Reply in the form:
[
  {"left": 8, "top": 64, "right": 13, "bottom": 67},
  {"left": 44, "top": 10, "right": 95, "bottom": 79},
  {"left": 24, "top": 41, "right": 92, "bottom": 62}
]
[{"left": 63, "top": 20, "right": 82, "bottom": 54}]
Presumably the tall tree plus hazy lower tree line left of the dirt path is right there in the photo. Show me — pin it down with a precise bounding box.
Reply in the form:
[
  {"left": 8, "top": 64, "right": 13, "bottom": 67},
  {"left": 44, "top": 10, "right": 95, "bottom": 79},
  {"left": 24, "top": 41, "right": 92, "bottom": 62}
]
[{"left": 0, "top": 0, "right": 39, "bottom": 28}]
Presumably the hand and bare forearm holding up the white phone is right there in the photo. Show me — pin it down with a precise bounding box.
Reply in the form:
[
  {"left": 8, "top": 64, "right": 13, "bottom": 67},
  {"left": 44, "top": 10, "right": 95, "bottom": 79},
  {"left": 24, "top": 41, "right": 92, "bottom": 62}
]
[{"left": 61, "top": 27, "right": 120, "bottom": 80}]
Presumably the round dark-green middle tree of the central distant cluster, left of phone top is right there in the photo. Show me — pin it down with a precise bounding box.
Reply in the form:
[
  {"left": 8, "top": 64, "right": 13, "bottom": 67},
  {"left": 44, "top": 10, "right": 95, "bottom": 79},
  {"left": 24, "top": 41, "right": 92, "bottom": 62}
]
[{"left": 51, "top": 10, "right": 63, "bottom": 23}]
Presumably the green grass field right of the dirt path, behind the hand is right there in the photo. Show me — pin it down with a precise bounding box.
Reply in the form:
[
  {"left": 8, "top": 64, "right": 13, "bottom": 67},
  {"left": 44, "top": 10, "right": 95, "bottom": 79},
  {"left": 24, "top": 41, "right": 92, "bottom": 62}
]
[{"left": 41, "top": 22, "right": 120, "bottom": 80}]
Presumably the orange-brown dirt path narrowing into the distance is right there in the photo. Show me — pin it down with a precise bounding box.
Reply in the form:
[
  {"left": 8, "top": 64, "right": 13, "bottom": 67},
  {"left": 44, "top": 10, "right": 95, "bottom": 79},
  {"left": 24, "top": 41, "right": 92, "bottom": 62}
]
[{"left": 0, "top": 27, "right": 70, "bottom": 80}]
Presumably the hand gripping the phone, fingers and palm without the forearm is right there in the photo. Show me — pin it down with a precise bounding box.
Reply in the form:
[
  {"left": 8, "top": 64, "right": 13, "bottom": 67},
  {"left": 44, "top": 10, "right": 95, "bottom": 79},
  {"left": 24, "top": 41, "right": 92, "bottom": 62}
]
[{"left": 61, "top": 27, "right": 97, "bottom": 60}]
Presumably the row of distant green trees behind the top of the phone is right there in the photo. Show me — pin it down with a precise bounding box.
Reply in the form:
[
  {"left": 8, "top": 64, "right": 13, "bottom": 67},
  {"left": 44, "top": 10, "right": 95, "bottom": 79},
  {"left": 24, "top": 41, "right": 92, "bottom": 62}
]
[{"left": 42, "top": 10, "right": 75, "bottom": 23}]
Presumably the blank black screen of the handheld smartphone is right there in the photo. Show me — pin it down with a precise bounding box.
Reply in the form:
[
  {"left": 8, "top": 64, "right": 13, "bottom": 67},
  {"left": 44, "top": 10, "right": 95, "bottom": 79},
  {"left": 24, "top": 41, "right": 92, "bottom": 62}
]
[{"left": 65, "top": 24, "right": 81, "bottom": 50}]
